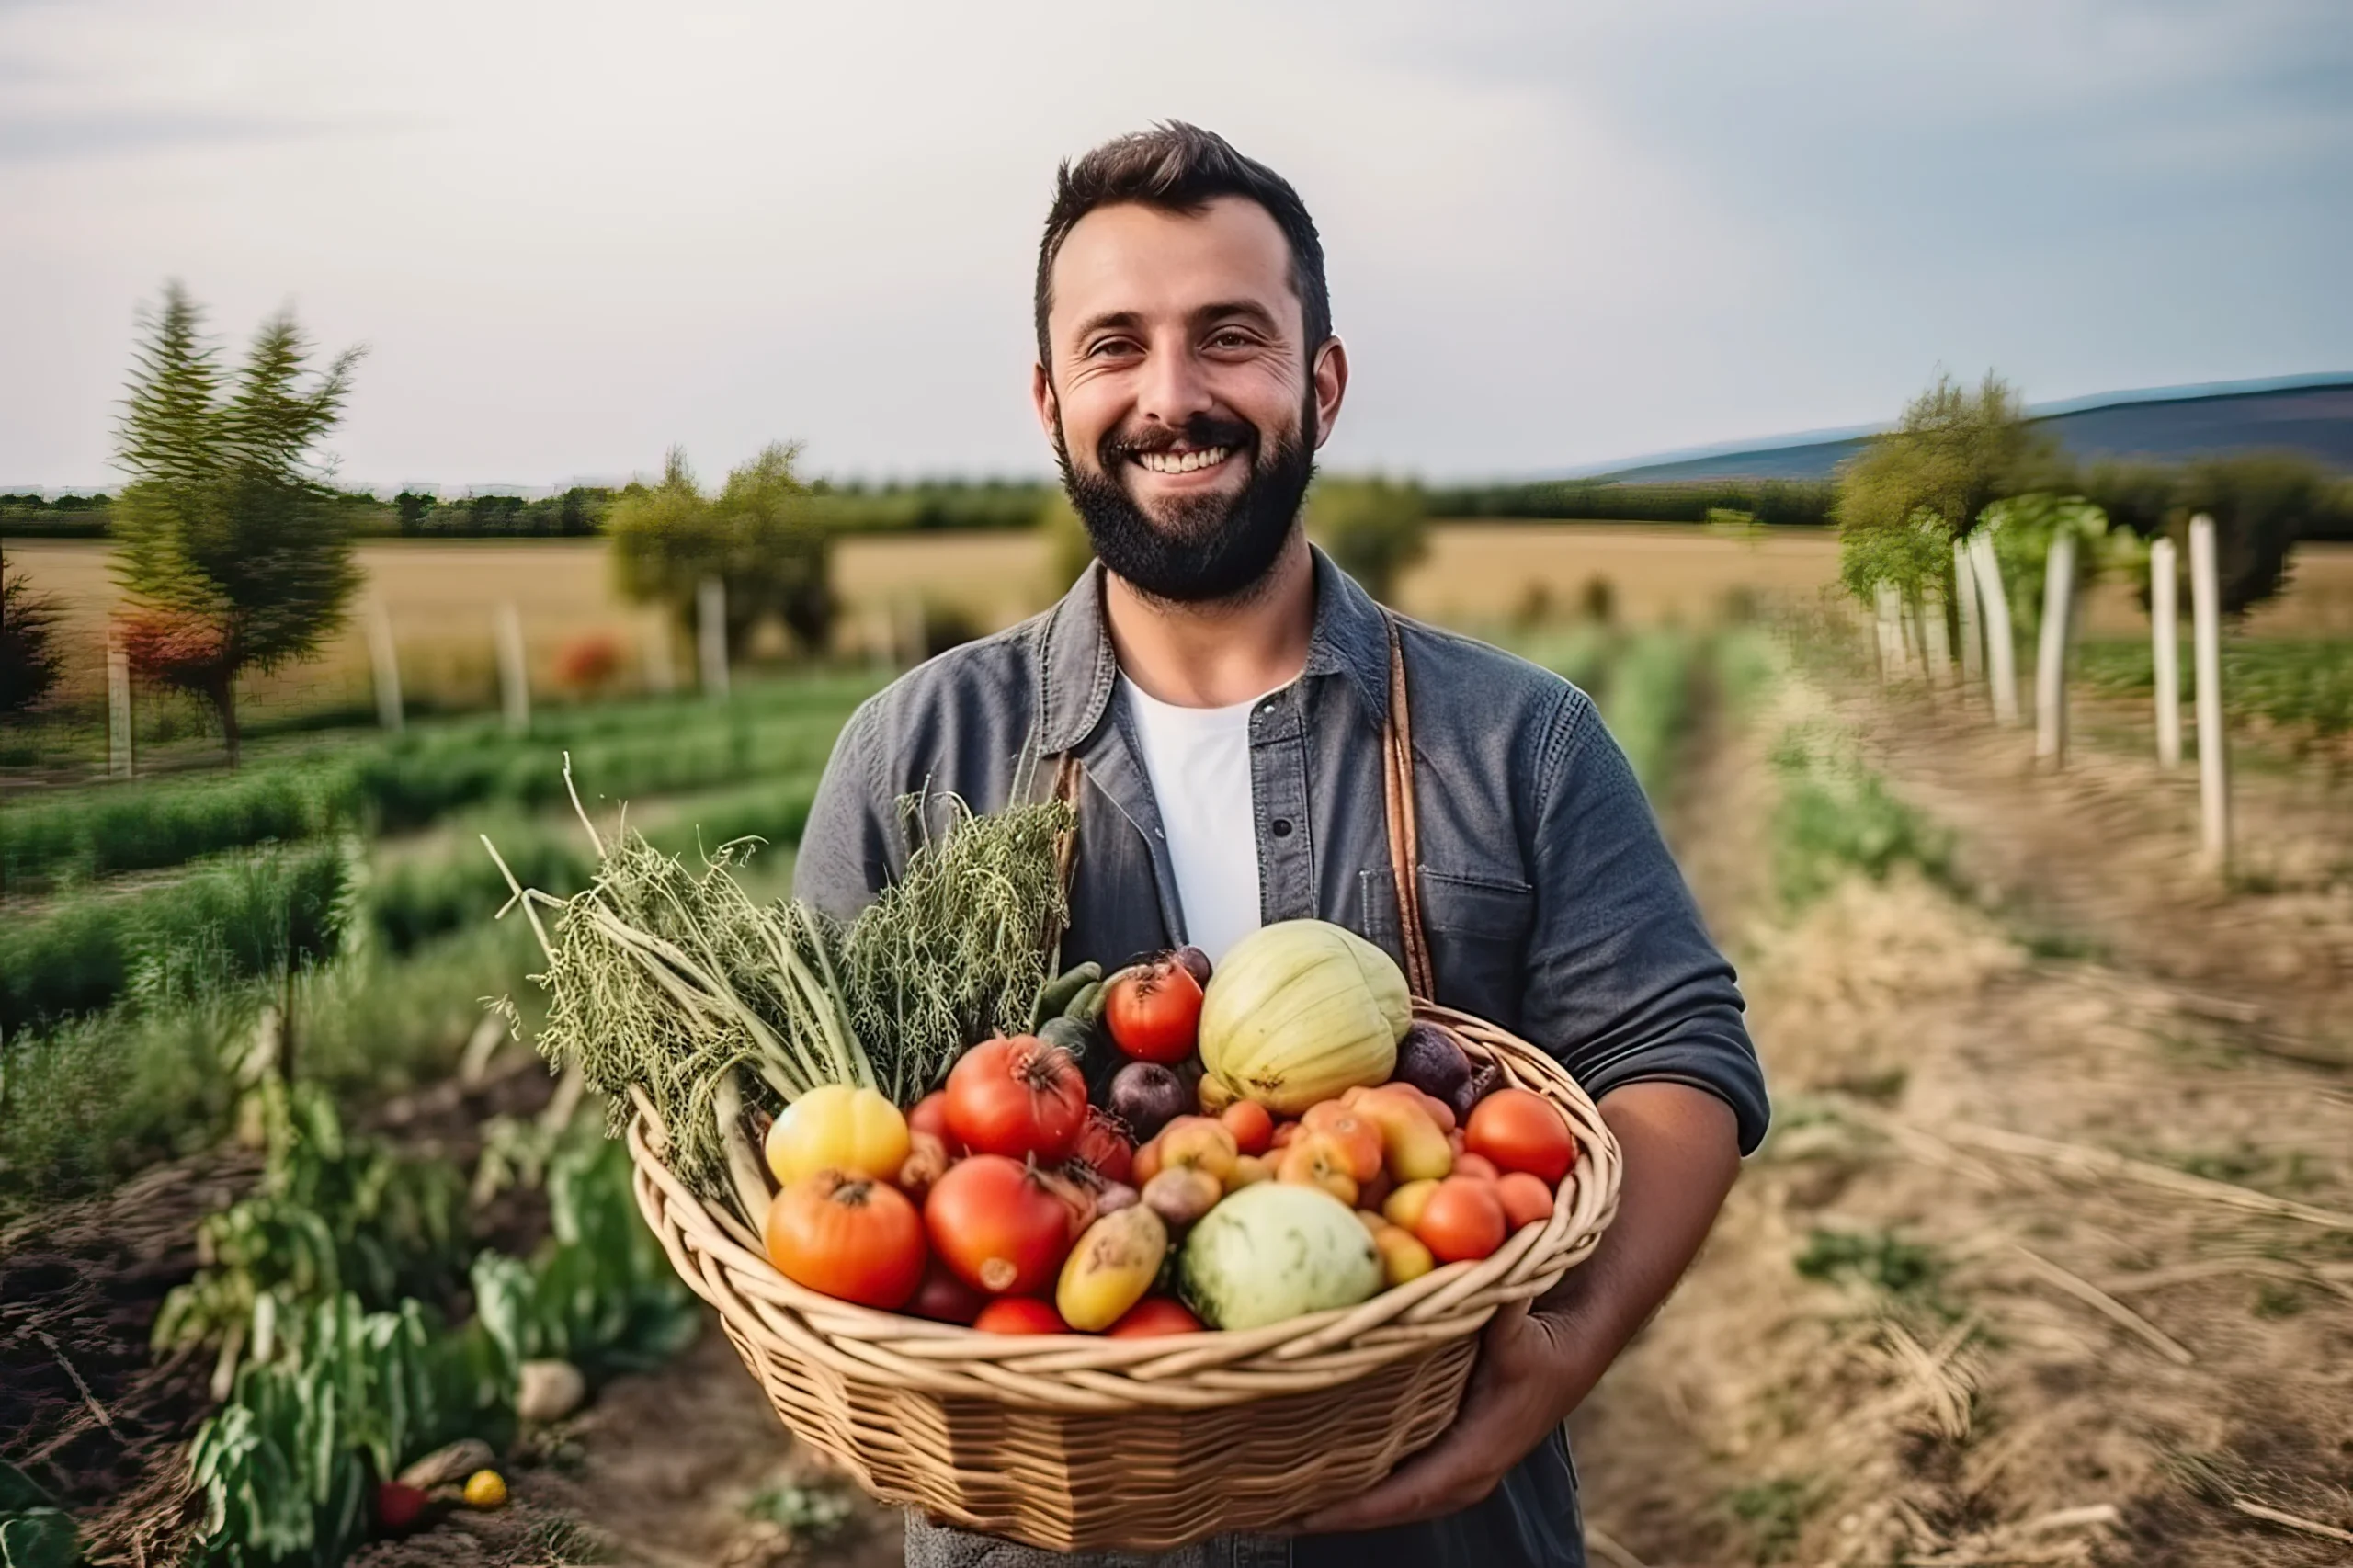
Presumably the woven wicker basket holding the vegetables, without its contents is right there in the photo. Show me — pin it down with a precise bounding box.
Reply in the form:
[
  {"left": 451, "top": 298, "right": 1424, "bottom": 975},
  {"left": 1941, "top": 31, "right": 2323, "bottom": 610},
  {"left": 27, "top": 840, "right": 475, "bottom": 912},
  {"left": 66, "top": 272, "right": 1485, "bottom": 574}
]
[{"left": 629, "top": 1003, "right": 1619, "bottom": 1551}]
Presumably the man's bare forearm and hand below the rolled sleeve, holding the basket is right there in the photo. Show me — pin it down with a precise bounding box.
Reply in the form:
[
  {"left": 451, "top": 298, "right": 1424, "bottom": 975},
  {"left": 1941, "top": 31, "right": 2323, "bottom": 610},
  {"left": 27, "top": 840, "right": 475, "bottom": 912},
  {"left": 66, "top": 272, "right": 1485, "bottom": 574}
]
[{"left": 1294, "top": 1083, "right": 1741, "bottom": 1535}]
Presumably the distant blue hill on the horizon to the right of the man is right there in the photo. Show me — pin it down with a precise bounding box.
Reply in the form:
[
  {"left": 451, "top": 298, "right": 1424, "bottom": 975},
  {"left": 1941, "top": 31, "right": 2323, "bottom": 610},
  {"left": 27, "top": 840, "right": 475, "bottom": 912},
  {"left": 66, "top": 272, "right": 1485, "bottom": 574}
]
[{"left": 1596, "top": 374, "right": 2353, "bottom": 485}]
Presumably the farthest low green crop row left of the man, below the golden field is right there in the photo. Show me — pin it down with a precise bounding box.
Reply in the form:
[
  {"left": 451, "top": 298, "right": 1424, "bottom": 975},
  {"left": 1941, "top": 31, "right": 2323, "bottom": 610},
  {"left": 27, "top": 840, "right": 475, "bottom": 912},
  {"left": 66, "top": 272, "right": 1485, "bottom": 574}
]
[{"left": 0, "top": 676, "right": 873, "bottom": 890}]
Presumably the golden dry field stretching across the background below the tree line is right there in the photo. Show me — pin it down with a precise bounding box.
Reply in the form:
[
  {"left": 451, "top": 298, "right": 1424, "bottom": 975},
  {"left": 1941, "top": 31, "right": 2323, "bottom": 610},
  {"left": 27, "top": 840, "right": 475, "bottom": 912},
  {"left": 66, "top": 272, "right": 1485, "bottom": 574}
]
[{"left": 7, "top": 523, "right": 2353, "bottom": 709}]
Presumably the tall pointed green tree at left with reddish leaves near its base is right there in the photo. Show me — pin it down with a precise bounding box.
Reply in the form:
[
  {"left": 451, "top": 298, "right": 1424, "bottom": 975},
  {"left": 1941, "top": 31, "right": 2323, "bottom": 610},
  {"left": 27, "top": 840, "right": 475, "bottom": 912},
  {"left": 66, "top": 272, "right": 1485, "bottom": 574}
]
[{"left": 113, "top": 282, "right": 362, "bottom": 767}]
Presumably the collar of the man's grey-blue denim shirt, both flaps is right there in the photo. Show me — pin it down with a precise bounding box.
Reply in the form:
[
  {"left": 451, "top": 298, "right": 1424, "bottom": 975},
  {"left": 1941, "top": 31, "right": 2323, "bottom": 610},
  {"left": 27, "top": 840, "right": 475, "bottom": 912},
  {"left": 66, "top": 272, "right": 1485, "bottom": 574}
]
[{"left": 1035, "top": 544, "right": 1388, "bottom": 756}]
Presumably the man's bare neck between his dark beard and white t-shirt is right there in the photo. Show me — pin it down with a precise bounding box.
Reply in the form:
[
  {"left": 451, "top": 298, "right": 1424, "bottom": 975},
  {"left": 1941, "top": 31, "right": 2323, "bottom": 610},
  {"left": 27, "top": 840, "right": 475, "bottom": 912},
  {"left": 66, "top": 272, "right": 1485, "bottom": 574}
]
[{"left": 1104, "top": 529, "right": 1315, "bottom": 709}]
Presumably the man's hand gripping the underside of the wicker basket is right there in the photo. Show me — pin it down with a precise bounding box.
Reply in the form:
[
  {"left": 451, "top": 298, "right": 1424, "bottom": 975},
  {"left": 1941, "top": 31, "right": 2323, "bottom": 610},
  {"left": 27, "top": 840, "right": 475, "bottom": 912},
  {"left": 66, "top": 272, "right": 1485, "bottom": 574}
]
[{"left": 1294, "top": 1302, "right": 1617, "bottom": 1535}]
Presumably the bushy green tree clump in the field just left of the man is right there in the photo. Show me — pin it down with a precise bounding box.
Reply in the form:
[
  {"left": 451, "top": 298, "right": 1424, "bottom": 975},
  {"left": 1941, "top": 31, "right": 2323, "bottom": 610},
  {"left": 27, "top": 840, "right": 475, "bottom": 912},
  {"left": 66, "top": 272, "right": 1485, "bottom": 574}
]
[{"left": 605, "top": 443, "right": 837, "bottom": 654}]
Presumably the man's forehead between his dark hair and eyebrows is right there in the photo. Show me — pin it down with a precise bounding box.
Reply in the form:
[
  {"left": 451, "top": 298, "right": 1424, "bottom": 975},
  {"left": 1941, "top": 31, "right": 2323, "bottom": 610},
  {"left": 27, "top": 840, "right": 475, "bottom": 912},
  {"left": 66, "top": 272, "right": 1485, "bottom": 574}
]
[{"left": 1047, "top": 196, "right": 1302, "bottom": 339}]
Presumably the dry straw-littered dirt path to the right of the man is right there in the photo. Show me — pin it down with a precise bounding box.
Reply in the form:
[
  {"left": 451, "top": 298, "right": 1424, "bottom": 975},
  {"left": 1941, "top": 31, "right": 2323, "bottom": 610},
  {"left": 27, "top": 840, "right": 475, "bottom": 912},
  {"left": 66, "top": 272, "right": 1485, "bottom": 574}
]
[{"left": 1579, "top": 649, "right": 2353, "bottom": 1568}]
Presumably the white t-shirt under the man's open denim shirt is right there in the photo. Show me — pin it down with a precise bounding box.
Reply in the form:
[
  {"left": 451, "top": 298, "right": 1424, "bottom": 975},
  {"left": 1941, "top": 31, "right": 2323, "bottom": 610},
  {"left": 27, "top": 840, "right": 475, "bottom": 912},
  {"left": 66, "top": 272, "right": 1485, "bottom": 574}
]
[{"left": 1120, "top": 676, "right": 1266, "bottom": 963}]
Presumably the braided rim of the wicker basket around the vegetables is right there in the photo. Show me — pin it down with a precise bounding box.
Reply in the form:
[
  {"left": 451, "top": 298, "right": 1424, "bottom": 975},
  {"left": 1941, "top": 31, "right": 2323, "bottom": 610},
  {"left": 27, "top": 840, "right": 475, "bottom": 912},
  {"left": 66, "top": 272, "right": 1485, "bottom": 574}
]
[{"left": 629, "top": 998, "right": 1623, "bottom": 1410}]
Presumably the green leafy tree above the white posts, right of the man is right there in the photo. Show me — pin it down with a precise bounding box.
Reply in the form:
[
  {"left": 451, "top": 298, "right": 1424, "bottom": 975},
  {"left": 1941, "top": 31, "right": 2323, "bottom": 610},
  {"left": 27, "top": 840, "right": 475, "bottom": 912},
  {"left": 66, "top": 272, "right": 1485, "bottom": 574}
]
[{"left": 1837, "top": 369, "right": 2056, "bottom": 600}]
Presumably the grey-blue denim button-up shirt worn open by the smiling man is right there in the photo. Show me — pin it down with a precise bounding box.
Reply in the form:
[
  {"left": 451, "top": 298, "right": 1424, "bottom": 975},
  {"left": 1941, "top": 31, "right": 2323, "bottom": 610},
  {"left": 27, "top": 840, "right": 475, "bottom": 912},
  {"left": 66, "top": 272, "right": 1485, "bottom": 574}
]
[{"left": 793, "top": 551, "right": 1768, "bottom": 1568}]
